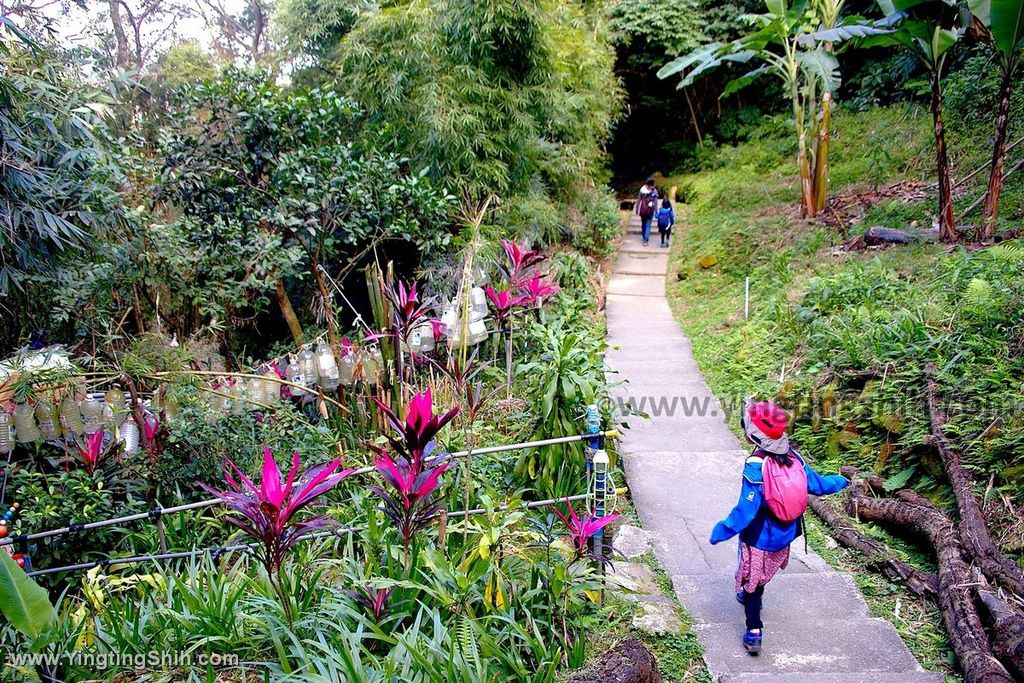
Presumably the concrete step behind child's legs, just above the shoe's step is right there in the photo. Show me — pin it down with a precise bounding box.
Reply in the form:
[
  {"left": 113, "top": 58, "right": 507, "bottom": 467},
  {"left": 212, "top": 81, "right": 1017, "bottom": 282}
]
[{"left": 672, "top": 569, "right": 867, "bottom": 630}]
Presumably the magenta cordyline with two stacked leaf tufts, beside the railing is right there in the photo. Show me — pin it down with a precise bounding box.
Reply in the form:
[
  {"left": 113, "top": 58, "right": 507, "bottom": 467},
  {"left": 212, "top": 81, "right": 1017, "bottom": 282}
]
[{"left": 370, "top": 389, "right": 459, "bottom": 551}]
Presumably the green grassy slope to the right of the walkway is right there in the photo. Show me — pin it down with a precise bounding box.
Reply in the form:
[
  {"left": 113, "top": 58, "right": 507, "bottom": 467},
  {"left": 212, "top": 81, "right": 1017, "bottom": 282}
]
[{"left": 667, "top": 106, "right": 1024, "bottom": 671}]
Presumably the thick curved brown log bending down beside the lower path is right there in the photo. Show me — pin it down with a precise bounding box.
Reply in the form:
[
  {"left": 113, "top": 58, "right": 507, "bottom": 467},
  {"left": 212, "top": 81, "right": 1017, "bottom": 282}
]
[{"left": 846, "top": 481, "right": 1013, "bottom": 683}]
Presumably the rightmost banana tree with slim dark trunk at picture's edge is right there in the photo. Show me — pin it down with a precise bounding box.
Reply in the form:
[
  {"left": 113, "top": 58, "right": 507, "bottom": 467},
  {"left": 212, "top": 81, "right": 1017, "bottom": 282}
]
[{"left": 969, "top": 0, "right": 1024, "bottom": 239}]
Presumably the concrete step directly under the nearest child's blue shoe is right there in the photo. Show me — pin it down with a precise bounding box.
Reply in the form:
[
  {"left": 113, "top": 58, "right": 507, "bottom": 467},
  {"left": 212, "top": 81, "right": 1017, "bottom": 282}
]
[{"left": 694, "top": 618, "right": 921, "bottom": 680}]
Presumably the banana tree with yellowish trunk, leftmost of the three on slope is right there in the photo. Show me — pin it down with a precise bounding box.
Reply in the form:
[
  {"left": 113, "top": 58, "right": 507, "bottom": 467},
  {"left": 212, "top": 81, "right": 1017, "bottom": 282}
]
[{"left": 657, "top": 0, "right": 885, "bottom": 216}]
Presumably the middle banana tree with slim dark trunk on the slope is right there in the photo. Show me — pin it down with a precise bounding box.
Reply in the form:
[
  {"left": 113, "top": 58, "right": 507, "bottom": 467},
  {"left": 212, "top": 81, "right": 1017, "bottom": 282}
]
[{"left": 863, "top": 0, "right": 964, "bottom": 242}]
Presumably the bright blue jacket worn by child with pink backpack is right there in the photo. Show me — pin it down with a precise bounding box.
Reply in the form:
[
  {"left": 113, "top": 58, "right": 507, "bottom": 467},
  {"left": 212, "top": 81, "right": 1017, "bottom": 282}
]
[{"left": 711, "top": 455, "right": 850, "bottom": 553}]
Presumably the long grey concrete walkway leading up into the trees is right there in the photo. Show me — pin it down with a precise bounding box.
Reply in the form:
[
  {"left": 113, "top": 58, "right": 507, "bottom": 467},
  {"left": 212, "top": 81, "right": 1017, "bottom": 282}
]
[{"left": 607, "top": 217, "right": 944, "bottom": 683}]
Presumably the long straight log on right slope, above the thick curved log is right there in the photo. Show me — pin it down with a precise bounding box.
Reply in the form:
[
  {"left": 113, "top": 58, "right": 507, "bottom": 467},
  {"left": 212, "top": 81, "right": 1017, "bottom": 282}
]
[{"left": 925, "top": 364, "right": 1024, "bottom": 597}]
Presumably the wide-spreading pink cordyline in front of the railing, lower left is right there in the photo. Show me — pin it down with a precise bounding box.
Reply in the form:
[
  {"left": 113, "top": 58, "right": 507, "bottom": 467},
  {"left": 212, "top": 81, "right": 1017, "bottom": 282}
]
[{"left": 200, "top": 446, "right": 352, "bottom": 580}]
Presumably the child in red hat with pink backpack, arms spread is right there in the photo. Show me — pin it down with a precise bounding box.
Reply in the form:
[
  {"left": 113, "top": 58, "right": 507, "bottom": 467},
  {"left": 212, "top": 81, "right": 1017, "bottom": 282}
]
[{"left": 711, "top": 401, "right": 850, "bottom": 655}]
